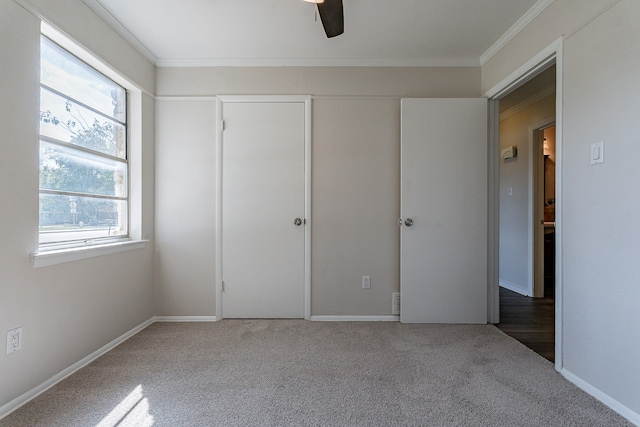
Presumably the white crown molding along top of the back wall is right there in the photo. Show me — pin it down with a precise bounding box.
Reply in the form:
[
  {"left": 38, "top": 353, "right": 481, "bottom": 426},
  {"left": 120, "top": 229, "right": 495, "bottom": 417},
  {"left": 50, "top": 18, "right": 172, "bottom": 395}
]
[{"left": 156, "top": 58, "right": 480, "bottom": 68}]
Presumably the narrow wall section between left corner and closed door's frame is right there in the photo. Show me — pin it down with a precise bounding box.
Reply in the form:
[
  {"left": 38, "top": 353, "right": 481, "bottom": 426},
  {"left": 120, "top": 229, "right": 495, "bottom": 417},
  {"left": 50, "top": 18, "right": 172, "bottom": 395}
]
[{"left": 155, "top": 99, "right": 216, "bottom": 316}]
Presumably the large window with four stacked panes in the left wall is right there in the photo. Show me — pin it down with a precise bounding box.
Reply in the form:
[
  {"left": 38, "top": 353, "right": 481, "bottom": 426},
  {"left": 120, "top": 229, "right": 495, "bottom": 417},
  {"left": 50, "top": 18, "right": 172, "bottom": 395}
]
[{"left": 39, "top": 36, "right": 129, "bottom": 251}]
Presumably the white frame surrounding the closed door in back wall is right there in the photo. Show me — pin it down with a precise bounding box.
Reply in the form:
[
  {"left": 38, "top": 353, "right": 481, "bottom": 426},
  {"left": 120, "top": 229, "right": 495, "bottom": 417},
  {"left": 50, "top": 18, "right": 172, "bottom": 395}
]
[{"left": 215, "top": 95, "right": 312, "bottom": 320}]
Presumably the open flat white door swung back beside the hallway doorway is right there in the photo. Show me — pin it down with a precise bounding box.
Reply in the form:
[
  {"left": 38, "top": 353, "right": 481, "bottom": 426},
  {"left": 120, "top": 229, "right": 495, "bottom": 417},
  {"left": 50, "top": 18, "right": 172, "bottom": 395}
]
[{"left": 400, "top": 98, "right": 487, "bottom": 323}]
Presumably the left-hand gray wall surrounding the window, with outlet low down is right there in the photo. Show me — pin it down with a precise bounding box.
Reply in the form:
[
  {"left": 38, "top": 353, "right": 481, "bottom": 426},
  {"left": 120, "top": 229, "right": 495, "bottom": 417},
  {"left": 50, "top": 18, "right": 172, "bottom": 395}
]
[{"left": 0, "top": 0, "right": 155, "bottom": 407}]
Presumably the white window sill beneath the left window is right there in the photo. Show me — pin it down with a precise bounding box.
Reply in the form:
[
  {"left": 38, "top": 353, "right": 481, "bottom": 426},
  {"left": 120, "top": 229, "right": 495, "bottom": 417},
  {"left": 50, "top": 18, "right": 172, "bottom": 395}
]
[{"left": 31, "top": 240, "right": 148, "bottom": 268}]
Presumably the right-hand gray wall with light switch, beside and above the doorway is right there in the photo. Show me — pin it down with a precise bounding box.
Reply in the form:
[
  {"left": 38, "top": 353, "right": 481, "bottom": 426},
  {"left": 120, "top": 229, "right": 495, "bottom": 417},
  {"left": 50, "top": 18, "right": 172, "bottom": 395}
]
[{"left": 482, "top": 0, "right": 640, "bottom": 420}]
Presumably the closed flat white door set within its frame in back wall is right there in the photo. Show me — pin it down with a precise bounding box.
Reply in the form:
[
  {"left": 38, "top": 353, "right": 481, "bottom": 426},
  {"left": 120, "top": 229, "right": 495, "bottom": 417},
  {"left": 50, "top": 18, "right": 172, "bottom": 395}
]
[{"left": 221, "top": 102, "right": 307, "bottom": 318}]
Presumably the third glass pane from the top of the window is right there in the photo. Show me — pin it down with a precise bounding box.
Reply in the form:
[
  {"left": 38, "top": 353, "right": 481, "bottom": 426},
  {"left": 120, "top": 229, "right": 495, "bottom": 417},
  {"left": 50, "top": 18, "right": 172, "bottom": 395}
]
[{"left": 40, "top": 141, "right": 127, "bottom": 197}]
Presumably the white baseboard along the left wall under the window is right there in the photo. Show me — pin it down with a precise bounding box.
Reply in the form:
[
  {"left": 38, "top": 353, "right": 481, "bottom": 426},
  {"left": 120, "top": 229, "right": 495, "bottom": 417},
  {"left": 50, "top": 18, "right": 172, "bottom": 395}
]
[{"left": 0, "top": 318, "right": 154, "bottom": 419}]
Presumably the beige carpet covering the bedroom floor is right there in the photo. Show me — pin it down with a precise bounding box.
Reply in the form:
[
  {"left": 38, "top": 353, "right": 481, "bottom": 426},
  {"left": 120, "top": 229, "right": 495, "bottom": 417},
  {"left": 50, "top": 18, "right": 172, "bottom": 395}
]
[{"left": 0, "top": 320, "right": 631, "bottom": 426}]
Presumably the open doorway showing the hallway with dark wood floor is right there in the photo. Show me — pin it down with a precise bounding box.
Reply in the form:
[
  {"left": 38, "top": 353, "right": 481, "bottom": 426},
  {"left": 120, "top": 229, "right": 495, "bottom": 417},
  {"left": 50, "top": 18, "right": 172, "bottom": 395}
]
[{"left": 498, "top": 65, "right": 557, "bottom": 362}]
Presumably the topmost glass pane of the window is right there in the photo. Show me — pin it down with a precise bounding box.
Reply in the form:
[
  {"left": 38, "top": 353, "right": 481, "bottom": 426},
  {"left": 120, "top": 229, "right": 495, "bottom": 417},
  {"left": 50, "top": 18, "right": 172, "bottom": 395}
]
[{"left": 40, "top": 37, "right": 126, "bottom": 122}]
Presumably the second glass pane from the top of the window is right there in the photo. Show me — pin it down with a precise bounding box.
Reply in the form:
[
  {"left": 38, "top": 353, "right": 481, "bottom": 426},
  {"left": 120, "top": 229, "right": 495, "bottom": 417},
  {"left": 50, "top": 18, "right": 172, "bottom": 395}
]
[{"left": 40, "top": 88, "right": 127, "bottom": 159}]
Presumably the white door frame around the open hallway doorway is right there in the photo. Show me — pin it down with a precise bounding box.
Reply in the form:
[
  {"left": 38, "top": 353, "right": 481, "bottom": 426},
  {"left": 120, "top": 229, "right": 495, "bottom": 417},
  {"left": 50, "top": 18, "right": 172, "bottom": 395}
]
[{"left": 483, "top": 37, "right": 563, "bottom": 371}]
